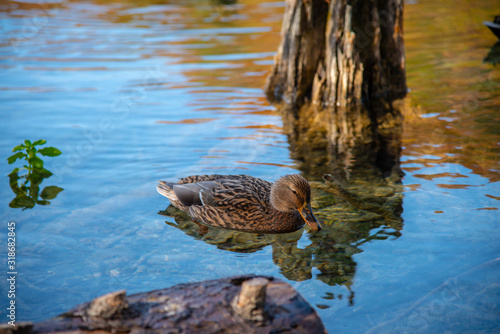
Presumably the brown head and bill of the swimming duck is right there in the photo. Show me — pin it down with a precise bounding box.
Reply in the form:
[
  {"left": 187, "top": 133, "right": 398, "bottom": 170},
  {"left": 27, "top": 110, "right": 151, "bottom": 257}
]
[{"left": 271, "top": 174, "right": 321, "bottom": 231}]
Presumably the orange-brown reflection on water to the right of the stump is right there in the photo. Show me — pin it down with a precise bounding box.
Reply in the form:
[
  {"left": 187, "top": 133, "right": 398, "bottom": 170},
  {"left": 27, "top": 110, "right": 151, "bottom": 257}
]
[{"left": 402, "top": 0, "right": 500, "bottom": 183}]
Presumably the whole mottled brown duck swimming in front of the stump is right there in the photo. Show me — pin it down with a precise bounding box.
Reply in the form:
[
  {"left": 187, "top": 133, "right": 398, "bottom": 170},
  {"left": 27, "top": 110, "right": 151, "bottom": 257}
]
[{"left": 156, "top": 174, "right": 321, "bottom": 233}]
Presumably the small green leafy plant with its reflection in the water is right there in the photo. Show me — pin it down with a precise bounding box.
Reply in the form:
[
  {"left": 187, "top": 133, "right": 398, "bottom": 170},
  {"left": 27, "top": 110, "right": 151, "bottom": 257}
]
[{"left": 7, "top": 139, "right": 64, "bottom": 210}]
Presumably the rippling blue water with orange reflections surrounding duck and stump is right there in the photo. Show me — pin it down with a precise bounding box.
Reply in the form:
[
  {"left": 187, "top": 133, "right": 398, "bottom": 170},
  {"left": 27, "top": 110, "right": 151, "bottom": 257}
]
[{"left": 0, "top": 1, "right": 500, "bottom": 333}]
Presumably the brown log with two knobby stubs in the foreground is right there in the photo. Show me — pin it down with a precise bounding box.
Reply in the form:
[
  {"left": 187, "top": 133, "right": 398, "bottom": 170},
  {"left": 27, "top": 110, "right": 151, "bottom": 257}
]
[{"left": 0, "top": 275, "right": 326, "bottom": 334}]
